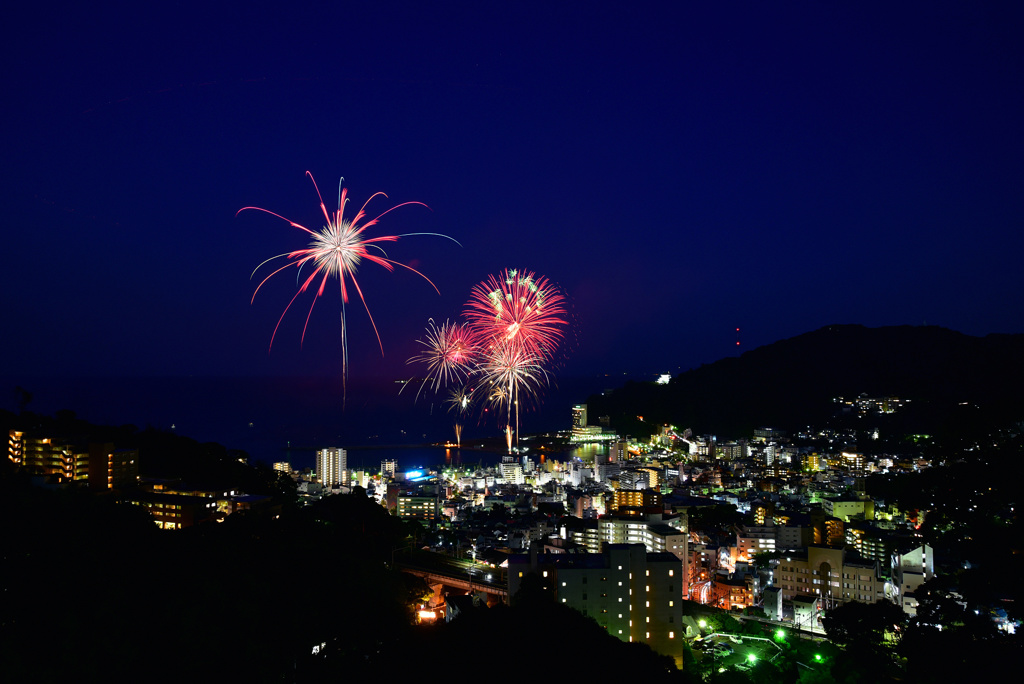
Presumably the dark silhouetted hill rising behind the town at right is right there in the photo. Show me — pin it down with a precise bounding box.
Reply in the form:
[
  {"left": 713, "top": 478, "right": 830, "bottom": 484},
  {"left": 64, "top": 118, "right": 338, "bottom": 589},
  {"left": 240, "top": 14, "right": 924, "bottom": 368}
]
[{"left": 588, "top": 325, "right": 1024, "bottom": 436}]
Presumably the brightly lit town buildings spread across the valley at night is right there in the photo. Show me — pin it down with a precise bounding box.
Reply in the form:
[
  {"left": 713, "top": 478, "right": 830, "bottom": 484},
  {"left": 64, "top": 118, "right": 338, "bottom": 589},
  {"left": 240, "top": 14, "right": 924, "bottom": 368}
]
[{"left": 8, "top": 387, "right": 1019, "bottom": 670}]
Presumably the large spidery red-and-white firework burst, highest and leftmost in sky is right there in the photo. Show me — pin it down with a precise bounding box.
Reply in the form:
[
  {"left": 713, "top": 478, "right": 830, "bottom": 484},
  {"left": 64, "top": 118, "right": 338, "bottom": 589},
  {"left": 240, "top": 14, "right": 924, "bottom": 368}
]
[{"left": 236, "top": 171, "right": 459, "bottom": 389}]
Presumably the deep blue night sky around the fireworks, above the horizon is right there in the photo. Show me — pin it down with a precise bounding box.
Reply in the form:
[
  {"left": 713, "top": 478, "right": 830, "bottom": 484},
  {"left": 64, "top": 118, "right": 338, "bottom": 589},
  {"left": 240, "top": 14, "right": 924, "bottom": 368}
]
[{"left": 0, "top": 2, "right": 1024, "bottom": 376}]
